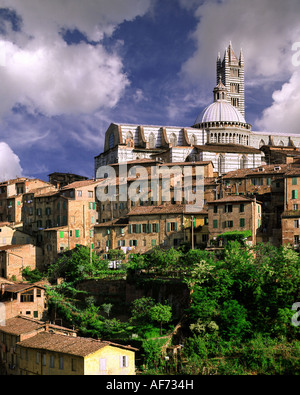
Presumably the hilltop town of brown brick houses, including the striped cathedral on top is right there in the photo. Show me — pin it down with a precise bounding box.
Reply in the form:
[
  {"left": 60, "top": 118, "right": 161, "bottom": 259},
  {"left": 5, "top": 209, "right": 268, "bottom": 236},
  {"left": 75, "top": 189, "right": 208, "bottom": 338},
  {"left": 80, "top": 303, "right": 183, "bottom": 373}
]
[{"left": 0, "top": 44, "right": 300, "bottom": 375}]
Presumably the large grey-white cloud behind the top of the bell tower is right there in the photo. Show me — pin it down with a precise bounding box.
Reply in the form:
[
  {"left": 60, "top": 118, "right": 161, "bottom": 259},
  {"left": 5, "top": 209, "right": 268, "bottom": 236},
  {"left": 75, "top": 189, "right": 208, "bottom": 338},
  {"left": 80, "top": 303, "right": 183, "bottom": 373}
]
[{"left": 181, "top": 0, "right": 300, "bottom": 83}]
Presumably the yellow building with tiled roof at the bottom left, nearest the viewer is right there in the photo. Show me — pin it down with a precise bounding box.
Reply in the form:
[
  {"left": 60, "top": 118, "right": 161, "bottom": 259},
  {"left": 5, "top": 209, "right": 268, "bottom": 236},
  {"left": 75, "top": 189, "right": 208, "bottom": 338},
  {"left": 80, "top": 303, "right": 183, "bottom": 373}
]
[{"left": 17, "top": 332, "right": 137, "bottom": 376}]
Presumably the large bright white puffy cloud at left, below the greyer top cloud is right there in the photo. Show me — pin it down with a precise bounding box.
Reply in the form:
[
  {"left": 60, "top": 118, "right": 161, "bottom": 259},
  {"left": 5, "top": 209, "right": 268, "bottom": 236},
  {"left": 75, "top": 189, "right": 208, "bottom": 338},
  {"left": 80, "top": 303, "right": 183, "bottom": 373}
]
[{"left": 0, "top": 41, "right": 129, "bottom": 116}]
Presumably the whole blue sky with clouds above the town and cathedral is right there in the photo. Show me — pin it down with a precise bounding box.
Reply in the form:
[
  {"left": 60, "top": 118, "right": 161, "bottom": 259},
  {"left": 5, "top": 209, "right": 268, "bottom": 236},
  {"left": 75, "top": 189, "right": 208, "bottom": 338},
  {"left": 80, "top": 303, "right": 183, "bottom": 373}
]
[{"left": 0, "top": 0, "right": 300, "bottom": 181}]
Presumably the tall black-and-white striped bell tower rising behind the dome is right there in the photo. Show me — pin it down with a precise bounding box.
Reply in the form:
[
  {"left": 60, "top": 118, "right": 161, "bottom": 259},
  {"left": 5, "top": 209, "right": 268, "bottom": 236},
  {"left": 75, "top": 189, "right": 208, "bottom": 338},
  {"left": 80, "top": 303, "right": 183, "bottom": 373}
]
[{"left": 217, "top": 41, "right": 245, "bottom": 117}]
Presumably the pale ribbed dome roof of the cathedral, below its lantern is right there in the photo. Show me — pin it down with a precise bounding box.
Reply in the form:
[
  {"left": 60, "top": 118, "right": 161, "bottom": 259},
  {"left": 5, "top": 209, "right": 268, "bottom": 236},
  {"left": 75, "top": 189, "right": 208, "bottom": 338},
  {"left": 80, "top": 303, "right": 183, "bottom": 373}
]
[{"left": 195, "top": 100, "right": 246, "bottom": 125}]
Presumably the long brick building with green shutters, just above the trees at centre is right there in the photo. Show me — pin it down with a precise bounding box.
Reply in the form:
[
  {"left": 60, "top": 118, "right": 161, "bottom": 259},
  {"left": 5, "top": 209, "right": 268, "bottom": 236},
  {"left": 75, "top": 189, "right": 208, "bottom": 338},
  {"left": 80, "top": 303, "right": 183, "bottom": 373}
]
[{"left": 94, "top": 204, "right": 208, "bottom": 254}]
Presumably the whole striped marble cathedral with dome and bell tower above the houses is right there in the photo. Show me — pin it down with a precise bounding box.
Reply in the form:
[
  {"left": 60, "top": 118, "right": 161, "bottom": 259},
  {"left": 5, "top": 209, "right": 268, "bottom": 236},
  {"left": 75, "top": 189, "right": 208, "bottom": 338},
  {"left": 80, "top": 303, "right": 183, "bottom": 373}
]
[{"left": 95, "top": 43, "right": 300, "bottom": 175}]
